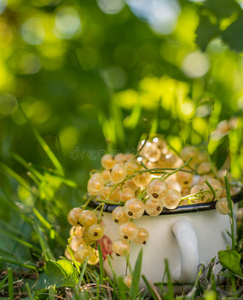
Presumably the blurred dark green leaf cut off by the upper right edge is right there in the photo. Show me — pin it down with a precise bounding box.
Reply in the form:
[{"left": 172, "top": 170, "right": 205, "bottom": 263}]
[{"left": 222, "top": 15, "right": 243, "bottom": 51}]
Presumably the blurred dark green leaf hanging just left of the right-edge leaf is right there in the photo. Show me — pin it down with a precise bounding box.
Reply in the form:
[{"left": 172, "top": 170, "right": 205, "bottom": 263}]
[{"left": 195, "top": 16, "right": 220, "bottom": 51}]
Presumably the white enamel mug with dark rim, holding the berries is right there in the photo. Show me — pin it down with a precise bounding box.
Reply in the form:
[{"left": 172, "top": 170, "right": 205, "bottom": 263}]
[{"left": 96, "top": 194, "right": 242, "bottom": 288}]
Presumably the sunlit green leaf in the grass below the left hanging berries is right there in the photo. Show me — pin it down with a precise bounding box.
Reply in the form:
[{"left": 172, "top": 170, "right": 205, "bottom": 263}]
[{"left": 35, "top": 260, "right": 78, "bottom": 290}]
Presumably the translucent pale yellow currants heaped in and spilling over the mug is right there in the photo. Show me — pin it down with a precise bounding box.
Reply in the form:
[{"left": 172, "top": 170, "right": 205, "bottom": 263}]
[{"left": 66, "top": 137, "right": 235, "bottom": 282}]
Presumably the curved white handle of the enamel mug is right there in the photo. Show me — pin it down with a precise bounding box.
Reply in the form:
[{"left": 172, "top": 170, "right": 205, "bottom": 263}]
[{"left": 172, "top": 219, "right": 199, "bottom": 283}]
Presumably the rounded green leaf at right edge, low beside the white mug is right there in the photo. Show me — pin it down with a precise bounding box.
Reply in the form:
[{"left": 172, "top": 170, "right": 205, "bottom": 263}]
[{"left": 218, "top": 250, "right": 243, "bottom": 278}]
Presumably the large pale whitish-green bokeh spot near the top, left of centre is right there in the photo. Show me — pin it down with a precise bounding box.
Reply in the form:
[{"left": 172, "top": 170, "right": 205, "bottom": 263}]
[{"left": 54, "top": 7, "right": 82, "bottom": 39}]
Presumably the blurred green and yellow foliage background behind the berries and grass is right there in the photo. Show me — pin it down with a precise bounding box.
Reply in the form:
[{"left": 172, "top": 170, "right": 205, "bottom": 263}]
[{"left": 0, "top": 0, "right": 243, "bottom": 258}]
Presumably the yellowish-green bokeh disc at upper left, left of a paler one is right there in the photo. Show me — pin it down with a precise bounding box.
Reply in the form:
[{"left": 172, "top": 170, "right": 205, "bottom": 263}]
[{"left": 21, "top": 18, "right": 45, "bottom": 45}]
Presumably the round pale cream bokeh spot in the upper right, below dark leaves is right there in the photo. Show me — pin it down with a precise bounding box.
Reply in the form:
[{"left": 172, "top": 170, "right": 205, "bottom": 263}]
[{"left": 182, "top": 51, "right": 210, "bottom": 78}]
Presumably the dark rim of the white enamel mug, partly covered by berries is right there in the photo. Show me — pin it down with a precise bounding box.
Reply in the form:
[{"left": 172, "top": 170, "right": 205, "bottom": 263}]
[{"left": 91, "top": 188, "right": 243, "bottom": 216}]
